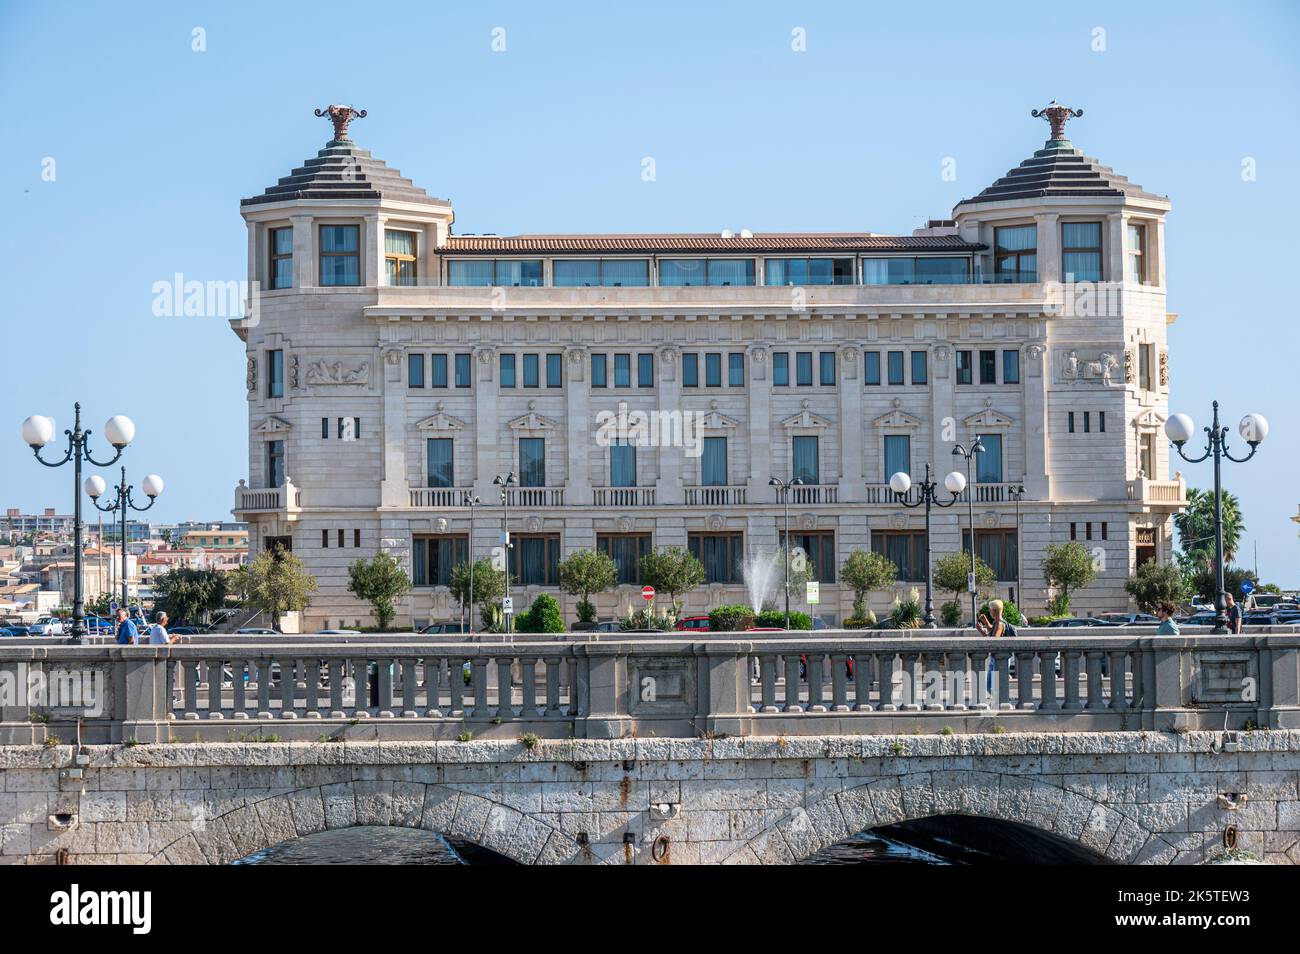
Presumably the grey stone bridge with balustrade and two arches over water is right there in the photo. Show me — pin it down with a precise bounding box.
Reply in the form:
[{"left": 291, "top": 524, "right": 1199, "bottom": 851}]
[{"left": 0, "top": 628, "right": 1300, "bottom": 864}]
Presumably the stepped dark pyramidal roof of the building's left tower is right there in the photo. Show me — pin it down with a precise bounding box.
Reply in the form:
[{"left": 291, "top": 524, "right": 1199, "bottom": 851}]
[{"left": 239, "top": 139, "right": 447, "bottom": 207}]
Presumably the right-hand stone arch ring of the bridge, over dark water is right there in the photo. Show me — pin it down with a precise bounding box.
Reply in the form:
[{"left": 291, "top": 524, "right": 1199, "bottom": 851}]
[{"left": 724, "top": 771, "right": 1174, "bottom": 864}]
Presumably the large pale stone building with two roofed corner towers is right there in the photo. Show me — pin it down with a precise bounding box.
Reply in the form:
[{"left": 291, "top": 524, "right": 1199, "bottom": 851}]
[{"left": 231, "top": 103, "right": 1184, "bottom": 626}]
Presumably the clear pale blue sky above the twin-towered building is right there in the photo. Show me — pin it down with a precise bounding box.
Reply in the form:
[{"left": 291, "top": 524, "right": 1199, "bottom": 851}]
[{"left": 0, "top": 0, "right": 1300, "bottom": 586}]
